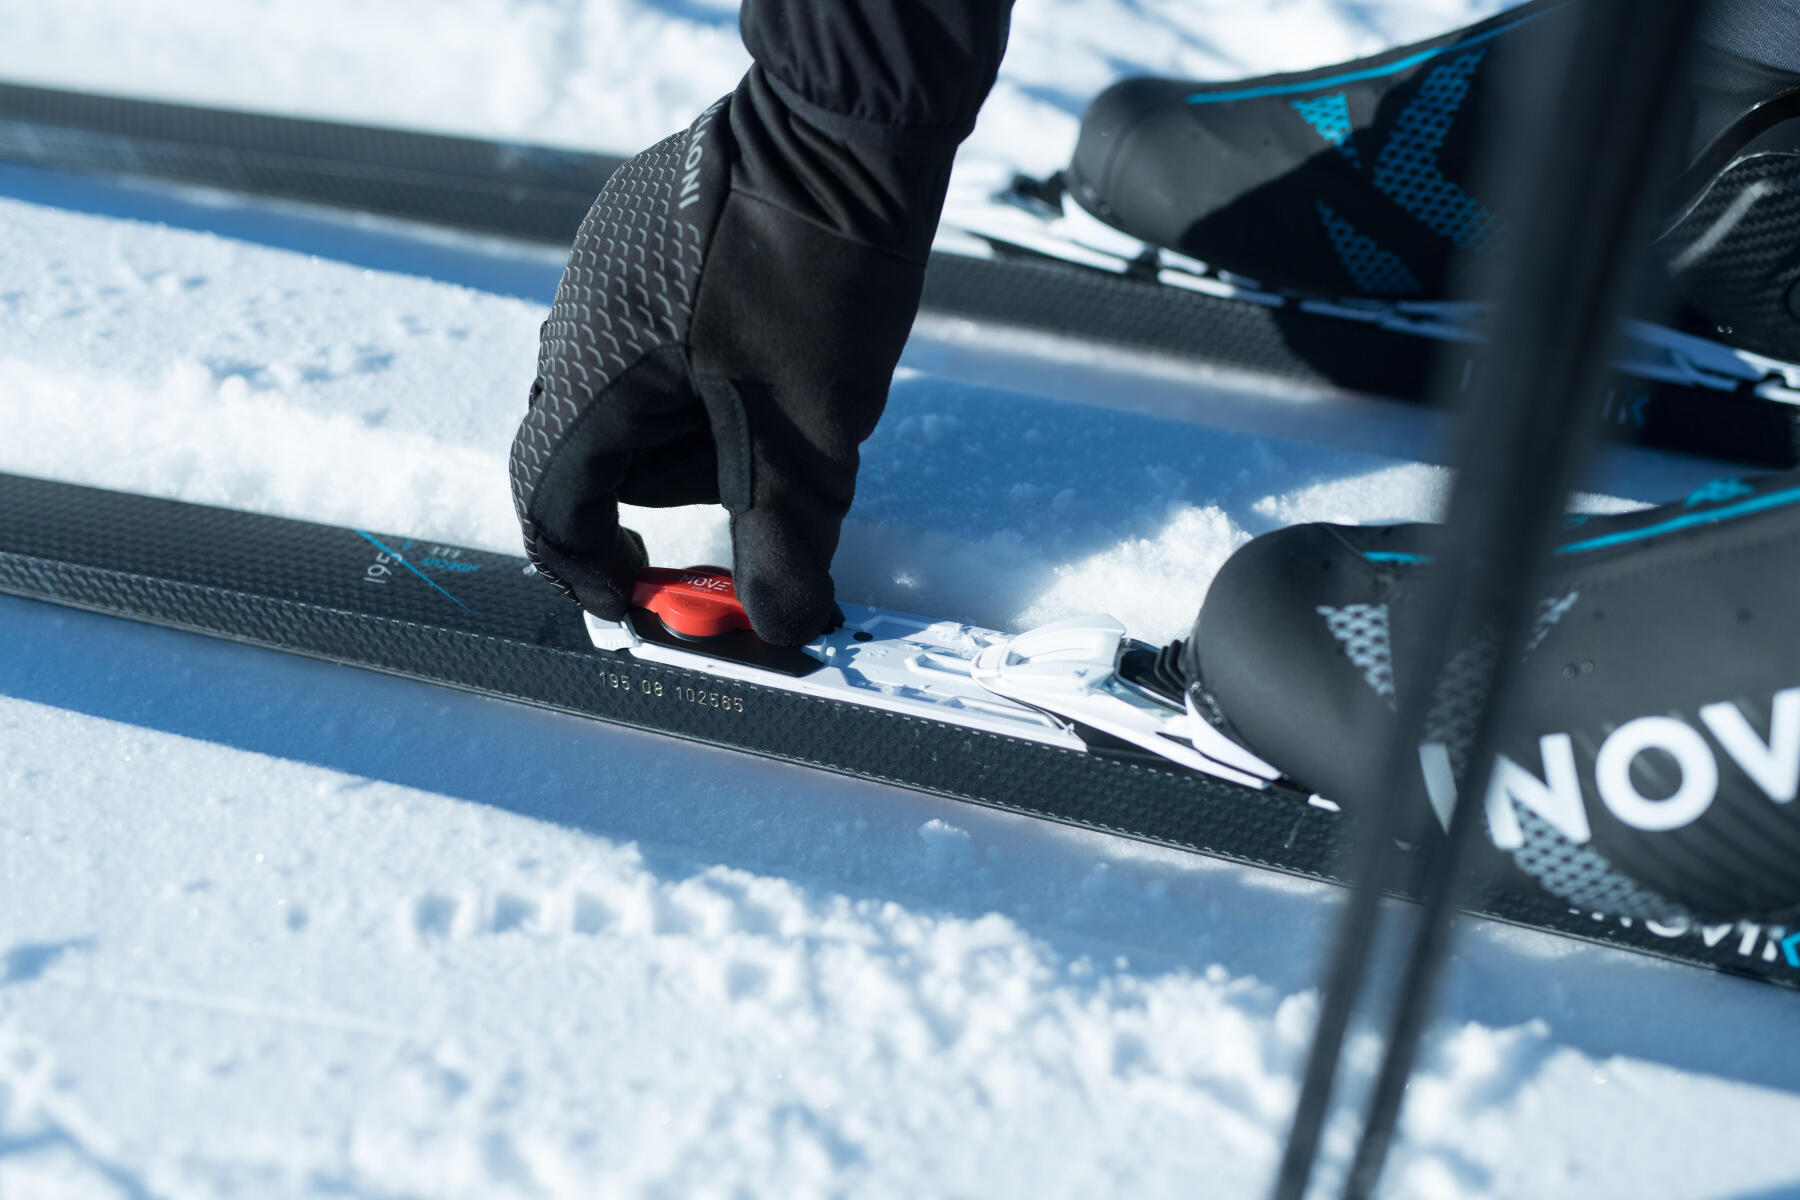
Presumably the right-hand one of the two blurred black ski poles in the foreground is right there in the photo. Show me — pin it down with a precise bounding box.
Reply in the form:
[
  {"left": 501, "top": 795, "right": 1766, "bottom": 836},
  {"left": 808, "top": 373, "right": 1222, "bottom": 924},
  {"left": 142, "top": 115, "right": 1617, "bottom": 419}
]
[{"left": 1345, "top": 0, "right": 1699, "bottom": 1200}]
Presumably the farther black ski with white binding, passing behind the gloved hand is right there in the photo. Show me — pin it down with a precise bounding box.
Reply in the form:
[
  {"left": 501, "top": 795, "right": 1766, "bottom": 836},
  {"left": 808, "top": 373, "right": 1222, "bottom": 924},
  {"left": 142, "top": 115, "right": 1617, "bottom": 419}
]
[{"left": 0, "top": 85, "right": 1800, "bottom": 468}]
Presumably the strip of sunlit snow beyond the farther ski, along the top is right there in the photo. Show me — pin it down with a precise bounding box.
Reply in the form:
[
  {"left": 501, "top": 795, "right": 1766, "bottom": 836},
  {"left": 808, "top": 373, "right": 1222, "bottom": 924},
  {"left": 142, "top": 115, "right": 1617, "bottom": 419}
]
[{"left": 0, "top": 0, "right": 1505, "bottom": 159}]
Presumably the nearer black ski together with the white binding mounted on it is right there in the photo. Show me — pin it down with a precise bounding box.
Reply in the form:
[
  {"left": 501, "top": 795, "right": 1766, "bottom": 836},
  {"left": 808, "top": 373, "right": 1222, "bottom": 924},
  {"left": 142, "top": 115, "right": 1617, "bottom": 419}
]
[{"left": 0, "top": 475, "right": 1800, "bottom": 988}]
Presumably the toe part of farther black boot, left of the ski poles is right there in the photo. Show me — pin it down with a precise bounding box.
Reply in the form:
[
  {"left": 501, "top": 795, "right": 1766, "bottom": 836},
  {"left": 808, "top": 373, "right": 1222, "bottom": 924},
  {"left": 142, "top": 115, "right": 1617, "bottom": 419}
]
[{"left": 1067, "top": 0, "right": 1568, "bottom": 299}]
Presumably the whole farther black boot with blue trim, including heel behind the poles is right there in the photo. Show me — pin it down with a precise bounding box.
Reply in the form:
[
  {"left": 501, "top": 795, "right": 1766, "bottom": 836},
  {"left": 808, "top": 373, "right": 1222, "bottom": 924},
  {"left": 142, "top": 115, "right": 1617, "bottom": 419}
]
[{"left": 1064, "top": 0, "right": 1800, "bottom": 360}]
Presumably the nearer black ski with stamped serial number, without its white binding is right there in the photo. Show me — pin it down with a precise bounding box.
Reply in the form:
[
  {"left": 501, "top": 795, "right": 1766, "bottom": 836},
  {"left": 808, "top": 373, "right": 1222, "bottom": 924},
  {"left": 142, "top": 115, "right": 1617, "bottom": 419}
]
[{"left": 0, "top": 475, "right": 1800, "bottom": 988}]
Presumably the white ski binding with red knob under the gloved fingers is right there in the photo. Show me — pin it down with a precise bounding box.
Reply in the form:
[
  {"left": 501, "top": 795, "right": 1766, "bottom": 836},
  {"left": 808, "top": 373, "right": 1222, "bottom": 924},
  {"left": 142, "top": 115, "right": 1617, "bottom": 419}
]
[{"left": 585, "top": 567, "right": 1280, "bottom": 788}]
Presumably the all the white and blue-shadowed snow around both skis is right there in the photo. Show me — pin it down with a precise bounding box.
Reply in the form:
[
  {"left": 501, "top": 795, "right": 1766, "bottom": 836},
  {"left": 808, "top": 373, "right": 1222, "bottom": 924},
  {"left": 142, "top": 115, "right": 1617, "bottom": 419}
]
[{"left": 0, "top": 0, "right": 1800, "bottom": 1200}]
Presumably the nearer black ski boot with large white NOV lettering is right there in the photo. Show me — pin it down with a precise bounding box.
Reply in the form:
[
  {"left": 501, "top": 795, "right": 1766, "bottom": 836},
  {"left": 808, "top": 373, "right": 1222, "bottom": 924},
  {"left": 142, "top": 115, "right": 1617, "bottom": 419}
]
[{"left": 1183, "top": 473, "right": 1800, "bottom": 919}]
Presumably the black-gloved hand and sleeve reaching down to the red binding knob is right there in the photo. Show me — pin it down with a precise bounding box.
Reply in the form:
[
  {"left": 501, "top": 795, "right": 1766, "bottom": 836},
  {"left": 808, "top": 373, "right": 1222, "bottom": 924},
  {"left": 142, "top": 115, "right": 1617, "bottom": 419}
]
[{"left": 511, "top": 0, "right": 1004, "bottom": 644}]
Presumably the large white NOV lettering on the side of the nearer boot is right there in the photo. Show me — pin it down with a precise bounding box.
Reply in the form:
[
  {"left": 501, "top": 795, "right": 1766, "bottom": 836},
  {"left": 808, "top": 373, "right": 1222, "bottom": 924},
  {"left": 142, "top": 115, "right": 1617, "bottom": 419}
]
[{"left": 1418, "top": 687, "right": 1800, "bottom": 849}]
